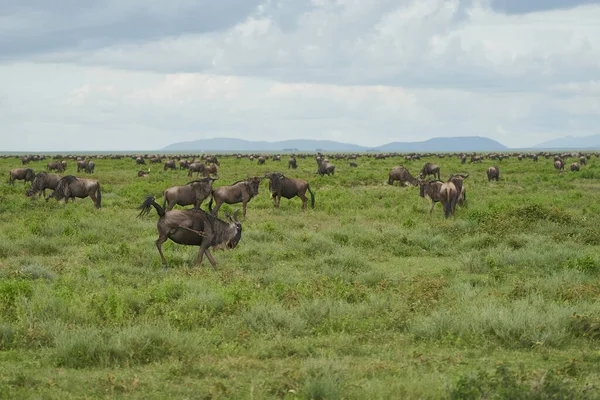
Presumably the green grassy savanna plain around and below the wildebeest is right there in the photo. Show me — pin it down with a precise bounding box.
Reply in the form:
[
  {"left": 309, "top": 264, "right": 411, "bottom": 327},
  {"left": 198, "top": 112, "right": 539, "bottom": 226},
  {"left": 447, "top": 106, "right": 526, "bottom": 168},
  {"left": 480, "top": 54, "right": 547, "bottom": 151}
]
[{"left": 0, "top": 152, "right": 600, "bottom": 399}]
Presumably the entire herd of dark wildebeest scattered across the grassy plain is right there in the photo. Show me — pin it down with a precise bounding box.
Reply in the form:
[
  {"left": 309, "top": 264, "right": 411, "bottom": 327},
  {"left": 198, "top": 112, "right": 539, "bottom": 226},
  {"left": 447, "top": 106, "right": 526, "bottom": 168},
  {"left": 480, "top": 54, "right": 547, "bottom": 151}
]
[{"left": 4, "top": 153, "right": 599, "bottom": 269}]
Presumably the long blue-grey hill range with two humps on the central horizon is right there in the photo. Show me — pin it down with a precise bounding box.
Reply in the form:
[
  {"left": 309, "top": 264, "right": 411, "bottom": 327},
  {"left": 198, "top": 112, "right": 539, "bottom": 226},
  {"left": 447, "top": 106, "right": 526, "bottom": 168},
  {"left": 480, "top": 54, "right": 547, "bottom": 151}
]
[{"left": 161, "top": 136, "right": 507, "bottom": 153}]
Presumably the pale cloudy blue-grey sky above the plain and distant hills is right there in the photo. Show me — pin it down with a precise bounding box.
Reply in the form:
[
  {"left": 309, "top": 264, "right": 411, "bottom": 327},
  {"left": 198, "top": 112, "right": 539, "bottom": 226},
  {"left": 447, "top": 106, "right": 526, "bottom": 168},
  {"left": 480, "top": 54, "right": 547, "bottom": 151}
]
[{"left": 0, "top": 0, "right": 600, "bottom": 152}]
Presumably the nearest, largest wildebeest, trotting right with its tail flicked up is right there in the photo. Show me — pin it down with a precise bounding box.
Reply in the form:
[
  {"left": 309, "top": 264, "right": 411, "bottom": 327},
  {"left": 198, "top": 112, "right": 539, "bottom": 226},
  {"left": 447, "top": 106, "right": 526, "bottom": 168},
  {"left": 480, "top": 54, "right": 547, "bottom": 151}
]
[{"left": 138, "top": 196, "right": 242, "bottom": 270}]
